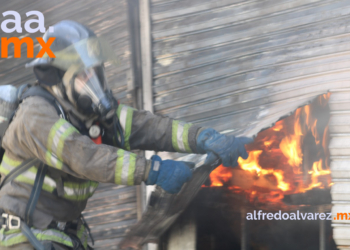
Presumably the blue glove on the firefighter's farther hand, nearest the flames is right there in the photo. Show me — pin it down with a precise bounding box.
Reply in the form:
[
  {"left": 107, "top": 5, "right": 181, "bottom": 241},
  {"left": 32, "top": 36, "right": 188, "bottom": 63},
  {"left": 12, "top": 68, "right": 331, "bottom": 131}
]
[{"left": 197, "top": 128, "right": 254, "bottom": 167}]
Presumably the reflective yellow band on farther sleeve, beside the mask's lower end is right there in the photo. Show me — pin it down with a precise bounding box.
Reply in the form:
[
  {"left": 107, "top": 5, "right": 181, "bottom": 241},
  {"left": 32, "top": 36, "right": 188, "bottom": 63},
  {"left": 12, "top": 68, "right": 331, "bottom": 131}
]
[{"left": 117, "top": 104, "right": 135, "bottom": 150}]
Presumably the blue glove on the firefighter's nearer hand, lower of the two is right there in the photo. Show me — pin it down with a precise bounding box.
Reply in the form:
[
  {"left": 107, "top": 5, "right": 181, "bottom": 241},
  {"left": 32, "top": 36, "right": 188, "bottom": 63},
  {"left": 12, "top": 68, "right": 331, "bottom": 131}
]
[{"left": 146, "top": 155, "right": 194, "bottom": 194}]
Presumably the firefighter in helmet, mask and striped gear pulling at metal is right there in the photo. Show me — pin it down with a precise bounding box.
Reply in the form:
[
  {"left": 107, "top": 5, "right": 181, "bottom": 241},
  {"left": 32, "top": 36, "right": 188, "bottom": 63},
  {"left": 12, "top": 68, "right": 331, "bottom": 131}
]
[{"left": 0, "top": 21, "right": 251, "bottom": 250}]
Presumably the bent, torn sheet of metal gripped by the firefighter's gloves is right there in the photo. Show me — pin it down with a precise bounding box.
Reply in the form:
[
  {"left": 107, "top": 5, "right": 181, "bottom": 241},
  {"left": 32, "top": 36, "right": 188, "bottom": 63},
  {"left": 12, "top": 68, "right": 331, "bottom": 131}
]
[{"left": 119, "top": 156, "right": 221, "bottom": 249}]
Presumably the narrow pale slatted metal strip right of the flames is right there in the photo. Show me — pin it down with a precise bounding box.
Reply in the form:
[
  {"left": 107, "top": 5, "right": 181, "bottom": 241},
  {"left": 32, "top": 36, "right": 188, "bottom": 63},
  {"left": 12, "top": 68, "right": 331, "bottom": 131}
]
[{"left": 329, "top": 88, "right": 350, "bottom": 249}]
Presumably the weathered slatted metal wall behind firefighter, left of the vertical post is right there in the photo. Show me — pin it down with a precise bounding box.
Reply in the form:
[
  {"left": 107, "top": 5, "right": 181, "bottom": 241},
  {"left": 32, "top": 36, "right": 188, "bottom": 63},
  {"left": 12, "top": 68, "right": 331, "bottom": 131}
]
[{"left": 0, "top": 0, "right": 137, "bottom": 249}]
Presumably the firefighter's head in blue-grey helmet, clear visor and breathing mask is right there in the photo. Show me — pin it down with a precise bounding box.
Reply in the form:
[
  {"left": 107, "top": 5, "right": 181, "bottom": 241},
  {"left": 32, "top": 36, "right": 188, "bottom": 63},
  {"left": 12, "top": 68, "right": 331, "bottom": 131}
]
[{"left": 26, "top": 20, "right": 124, "bottom": 147}]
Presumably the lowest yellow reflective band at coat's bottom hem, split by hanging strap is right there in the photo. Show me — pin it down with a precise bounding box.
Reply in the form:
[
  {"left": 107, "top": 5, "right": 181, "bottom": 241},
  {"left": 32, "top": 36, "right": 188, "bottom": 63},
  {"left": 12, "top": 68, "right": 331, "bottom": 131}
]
[{"left": 0, "top": 228, "right": 73, "bottom": 247}]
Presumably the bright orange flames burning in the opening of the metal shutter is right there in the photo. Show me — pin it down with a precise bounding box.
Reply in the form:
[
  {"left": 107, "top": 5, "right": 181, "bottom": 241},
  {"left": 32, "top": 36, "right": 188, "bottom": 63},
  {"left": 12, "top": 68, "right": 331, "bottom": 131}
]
[{"left": 206, "top": 93, "right": 332, "bottom": 202}]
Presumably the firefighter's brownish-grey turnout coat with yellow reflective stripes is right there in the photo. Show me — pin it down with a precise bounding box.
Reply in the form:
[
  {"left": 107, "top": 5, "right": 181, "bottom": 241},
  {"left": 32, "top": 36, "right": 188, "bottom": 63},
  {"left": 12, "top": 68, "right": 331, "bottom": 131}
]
[{"left": 0, "top": 96, "right": 200, "bottom": 246}]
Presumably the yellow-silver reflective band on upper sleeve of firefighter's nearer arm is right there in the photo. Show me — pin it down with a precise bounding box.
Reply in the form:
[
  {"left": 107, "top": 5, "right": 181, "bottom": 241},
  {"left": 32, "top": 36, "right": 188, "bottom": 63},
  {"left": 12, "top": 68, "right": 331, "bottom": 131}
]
[{"left": 46, "top": 119, "right": 78, "bottom": 169}]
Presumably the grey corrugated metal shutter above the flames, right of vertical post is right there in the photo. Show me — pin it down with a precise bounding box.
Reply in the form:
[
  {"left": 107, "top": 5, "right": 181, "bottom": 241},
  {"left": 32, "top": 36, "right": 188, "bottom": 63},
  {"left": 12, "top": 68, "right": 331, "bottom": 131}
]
[{"left": 150, "top": 0, "right": 350, "bottom": 137}]
